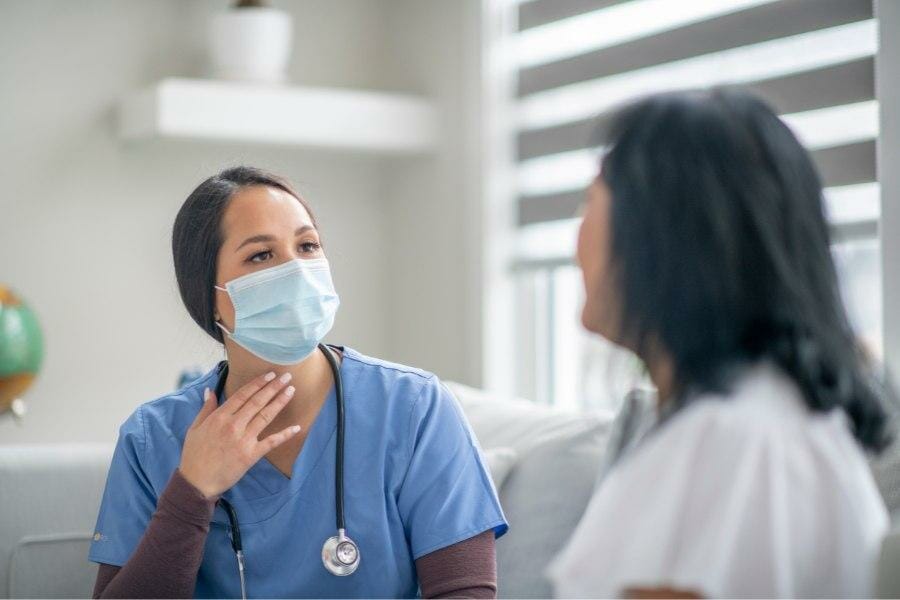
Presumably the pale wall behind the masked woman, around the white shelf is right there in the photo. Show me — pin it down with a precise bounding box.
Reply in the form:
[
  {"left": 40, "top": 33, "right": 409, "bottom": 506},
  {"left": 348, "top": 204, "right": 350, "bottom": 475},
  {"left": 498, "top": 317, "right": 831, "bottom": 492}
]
[{"left": 0, "top": 0, "right": 480, "bottom": 443}]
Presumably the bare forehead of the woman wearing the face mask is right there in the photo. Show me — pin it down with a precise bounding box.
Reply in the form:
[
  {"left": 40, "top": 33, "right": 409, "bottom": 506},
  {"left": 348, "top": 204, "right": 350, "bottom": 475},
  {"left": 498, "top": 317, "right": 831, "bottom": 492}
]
[{"left": 222, "top": 185, "right": 313, "bottom": 240}]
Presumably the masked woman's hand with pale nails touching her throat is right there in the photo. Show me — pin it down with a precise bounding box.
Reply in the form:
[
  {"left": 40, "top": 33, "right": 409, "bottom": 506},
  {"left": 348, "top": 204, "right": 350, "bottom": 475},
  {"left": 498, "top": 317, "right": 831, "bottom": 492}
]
[{"left": 178, "top": 373, "right": 300, "bottom": 498}]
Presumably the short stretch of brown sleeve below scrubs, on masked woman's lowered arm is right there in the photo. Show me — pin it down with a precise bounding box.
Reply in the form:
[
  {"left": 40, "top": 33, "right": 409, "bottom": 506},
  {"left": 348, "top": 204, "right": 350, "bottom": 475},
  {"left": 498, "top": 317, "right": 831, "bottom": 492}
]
[{"left": 416, "top": 530, "right": 497, "bottom": 598}]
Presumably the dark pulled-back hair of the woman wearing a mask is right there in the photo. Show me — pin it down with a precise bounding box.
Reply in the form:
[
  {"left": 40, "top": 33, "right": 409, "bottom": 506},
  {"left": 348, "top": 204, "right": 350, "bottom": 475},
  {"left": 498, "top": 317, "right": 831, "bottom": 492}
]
[{"left": 172, "top": 166, "right": 318, "bottom": 342}]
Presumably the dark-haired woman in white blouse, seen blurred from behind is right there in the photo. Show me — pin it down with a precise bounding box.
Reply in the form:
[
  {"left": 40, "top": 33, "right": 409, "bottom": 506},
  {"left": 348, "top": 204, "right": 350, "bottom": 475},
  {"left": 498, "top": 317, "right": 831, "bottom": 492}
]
[{"left": 550, "top": 90, "right": 893, "bottom": 597}]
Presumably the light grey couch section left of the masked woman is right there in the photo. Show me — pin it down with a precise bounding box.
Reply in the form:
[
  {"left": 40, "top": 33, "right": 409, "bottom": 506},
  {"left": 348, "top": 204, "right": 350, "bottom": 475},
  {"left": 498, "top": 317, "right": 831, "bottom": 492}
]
[{"left": 0, "top": 445, "right": 112, "bottom": 598}]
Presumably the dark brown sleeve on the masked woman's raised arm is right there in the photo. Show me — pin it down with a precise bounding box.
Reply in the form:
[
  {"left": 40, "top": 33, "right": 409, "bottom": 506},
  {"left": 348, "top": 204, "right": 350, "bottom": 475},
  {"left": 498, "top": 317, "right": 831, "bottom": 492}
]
[{"left": 93, "top": 469, "right": 215, "bottom": 598}]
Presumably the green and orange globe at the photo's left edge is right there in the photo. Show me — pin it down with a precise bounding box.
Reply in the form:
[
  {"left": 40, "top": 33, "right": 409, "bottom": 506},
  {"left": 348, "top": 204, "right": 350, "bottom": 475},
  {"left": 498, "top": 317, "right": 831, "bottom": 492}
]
[{"left": 0, "top": 285, "right": 44, "bottom": 413}]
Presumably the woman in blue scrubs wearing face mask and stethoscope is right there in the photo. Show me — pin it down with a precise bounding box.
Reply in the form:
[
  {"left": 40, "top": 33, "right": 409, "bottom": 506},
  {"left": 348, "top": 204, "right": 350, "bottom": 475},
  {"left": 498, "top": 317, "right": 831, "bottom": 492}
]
[{"left": 89, "top": 167, "right": 508, "bottom": 598}]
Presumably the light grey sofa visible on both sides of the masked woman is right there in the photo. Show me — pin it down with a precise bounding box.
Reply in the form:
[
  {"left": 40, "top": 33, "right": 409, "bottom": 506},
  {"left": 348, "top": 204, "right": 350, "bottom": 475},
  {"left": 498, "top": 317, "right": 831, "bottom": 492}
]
[{"left": 0, "top": 384, "right": 610, "bottom": 598}]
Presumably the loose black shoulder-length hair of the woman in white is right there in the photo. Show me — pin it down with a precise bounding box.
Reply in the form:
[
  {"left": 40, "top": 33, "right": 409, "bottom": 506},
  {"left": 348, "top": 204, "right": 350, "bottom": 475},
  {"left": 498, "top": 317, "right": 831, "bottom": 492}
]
[{"left": 600, "top": 89, "right": 894, "bottom": 450}]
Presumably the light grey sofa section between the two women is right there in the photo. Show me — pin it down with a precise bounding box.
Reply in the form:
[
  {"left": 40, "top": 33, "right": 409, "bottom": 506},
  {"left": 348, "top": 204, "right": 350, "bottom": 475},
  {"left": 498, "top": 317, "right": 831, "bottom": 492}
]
[{"left": 447, "top": 383, "right": 612, "bottom": 598}]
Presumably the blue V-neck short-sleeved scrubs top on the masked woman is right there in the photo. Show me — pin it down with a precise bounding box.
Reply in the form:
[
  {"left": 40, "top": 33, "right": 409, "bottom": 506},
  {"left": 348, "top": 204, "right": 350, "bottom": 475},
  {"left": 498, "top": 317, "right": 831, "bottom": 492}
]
[{"left": 88, "top": 348, "right": 508, "bottom": 598}]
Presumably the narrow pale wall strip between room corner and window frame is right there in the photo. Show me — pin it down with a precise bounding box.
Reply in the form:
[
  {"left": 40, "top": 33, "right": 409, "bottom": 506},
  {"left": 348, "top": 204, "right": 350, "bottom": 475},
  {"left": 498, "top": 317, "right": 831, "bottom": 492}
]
[{"left": 386, "top": 0, "right": 483, "bottom": 385}]
